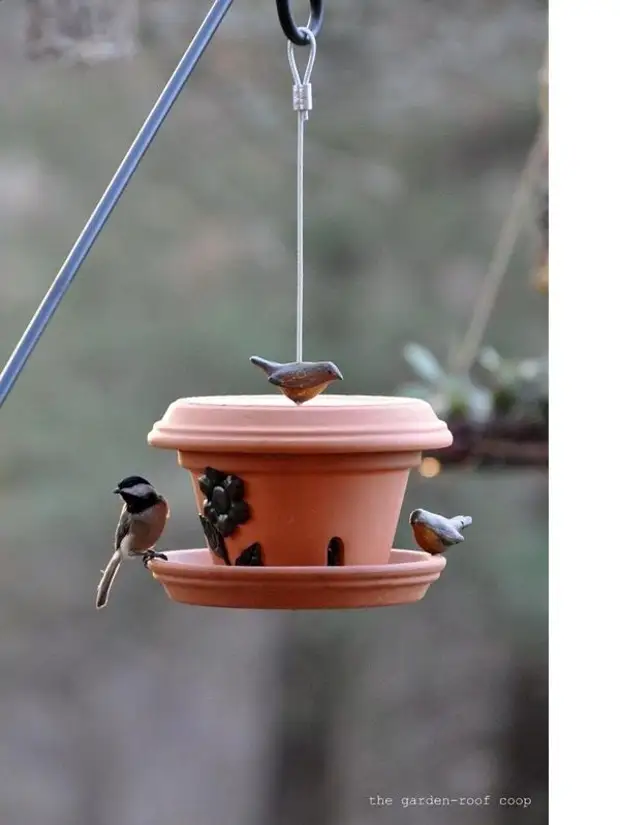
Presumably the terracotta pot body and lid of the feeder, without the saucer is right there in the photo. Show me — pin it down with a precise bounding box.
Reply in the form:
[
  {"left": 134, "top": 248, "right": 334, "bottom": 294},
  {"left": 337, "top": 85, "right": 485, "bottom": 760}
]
[{"left": 148, "top": 395, "right": 452, "bottom": 568}]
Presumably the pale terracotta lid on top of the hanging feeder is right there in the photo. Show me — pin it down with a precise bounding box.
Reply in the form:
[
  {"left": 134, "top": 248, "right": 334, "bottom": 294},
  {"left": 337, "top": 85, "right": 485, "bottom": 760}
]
[{"left": 148, "top": 395, "right": 452, "bottom": 453}]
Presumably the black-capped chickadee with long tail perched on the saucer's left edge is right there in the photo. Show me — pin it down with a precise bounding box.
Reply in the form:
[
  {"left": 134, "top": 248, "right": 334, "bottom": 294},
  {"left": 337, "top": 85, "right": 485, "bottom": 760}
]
[{"left": 96, "top": 476, "right": 170, "bottom": 610}]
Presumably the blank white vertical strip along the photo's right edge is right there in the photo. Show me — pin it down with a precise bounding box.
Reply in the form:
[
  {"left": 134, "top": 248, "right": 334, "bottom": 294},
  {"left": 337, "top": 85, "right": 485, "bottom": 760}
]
[{"left": 549, "top": 0, "right": 620, "bottom": 825}]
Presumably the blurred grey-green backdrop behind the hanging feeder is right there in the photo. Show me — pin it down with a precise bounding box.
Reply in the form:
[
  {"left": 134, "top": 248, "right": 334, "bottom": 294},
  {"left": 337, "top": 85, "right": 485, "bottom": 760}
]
[{"left": 0, "top": 0, "right": 547, "bottom": 825}]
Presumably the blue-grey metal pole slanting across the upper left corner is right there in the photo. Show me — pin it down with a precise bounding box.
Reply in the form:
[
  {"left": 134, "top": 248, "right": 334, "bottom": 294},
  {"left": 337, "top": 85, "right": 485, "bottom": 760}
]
[{"left": 0, "top": 0, "right": 233, "bottom": 407}]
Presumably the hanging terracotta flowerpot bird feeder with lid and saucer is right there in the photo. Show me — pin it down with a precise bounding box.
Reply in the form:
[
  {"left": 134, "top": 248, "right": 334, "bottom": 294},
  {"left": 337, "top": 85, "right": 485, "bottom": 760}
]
[{"left": 148, "top": 395, "right": 452, "bottom": 608}]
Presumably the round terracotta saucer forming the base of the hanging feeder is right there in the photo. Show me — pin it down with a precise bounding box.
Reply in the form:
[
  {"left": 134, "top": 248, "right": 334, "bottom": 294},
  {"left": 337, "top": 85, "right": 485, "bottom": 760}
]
[{"left": 149, "top": 548, "right": 446, "bottom": 610}]
